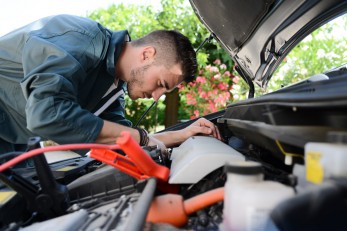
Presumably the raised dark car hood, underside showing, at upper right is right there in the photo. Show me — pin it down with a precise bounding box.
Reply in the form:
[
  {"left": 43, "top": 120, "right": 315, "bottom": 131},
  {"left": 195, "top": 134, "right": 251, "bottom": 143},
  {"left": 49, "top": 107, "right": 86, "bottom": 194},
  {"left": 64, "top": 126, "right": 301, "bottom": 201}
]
[{"left": 190, "top": 0, "right": 347, "bottom": 87}]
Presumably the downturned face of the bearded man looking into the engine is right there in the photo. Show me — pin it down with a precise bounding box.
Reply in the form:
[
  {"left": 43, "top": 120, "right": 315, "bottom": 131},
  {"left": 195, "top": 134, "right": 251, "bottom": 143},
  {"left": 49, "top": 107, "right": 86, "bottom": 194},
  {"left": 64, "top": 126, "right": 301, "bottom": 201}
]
[{"left": 127, "top": 63, "right": 183, "bottom": 101}]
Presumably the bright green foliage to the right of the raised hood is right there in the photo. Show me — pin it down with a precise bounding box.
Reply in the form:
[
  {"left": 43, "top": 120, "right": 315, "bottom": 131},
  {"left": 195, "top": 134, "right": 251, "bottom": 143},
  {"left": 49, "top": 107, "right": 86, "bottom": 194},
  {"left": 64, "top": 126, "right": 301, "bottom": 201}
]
[{"left": 268, "top": 15, "right": 347, "bottom": 92}]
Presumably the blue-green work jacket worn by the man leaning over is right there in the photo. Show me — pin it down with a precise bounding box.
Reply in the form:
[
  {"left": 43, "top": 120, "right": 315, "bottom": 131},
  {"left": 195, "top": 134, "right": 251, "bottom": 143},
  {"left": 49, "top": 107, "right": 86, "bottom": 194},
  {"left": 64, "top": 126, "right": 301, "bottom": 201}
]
[{"left": 0, "top": 15, "right": 131, "bottom": 144}]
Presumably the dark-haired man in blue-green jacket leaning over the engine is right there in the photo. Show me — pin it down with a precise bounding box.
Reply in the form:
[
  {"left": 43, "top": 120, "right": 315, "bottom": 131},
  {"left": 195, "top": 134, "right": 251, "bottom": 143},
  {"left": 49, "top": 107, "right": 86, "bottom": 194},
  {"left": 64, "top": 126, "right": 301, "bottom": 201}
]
[{"left": 0, "top": 15, "right": 220, "bottom": 153}]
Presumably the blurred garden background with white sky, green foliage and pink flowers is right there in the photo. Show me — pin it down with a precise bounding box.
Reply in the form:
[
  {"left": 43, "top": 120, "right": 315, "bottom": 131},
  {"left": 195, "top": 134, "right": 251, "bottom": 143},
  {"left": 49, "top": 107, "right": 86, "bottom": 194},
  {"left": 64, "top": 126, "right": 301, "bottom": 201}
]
[{"left": 0, "top": 0, "right": 347, "bottom": 132}]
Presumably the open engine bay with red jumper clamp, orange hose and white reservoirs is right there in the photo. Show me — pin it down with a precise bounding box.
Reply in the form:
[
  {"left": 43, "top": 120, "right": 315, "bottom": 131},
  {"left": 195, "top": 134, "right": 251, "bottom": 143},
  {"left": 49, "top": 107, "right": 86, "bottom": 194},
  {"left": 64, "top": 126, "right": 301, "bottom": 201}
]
[{"left": 0, "top": 69, "right": 347, "bottom": 230}]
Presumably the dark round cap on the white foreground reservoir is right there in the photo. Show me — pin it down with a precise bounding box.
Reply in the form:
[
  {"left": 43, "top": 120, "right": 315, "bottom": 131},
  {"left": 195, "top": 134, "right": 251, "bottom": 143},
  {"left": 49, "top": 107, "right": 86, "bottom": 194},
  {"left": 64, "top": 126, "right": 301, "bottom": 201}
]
[{"left": 224, "top": 161, "right": 263, "bottom": 175}]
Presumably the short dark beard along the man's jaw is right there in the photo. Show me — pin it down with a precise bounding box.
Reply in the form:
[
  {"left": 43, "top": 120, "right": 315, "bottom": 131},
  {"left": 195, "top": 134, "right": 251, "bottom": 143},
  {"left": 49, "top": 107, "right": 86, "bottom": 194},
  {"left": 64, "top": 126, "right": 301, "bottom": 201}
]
[{"left": 127, "top": 65, "right": 151, "bottom": 100}]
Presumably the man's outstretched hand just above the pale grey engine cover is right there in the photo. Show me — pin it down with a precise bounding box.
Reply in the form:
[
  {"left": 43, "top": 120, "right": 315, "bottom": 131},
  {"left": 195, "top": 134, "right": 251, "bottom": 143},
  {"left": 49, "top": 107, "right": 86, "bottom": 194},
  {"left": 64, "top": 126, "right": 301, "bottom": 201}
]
[{"left": 182, "top": 118, "right": 222, "bottom": 140}]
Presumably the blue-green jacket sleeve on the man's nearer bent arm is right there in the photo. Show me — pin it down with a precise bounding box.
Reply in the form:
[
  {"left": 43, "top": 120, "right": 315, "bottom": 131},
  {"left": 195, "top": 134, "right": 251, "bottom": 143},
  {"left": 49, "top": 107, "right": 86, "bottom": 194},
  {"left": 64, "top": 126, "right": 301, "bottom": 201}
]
[{"left": 21, "top": 37, "right": 103, "bottom": 143}]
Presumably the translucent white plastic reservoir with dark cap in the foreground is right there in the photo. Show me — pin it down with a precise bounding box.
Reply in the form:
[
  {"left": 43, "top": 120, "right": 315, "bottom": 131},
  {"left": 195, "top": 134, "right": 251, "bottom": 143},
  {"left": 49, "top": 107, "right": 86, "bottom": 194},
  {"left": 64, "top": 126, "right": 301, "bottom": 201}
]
[{"left": 221, "top": 161, "right": 294, "bottom": 231}]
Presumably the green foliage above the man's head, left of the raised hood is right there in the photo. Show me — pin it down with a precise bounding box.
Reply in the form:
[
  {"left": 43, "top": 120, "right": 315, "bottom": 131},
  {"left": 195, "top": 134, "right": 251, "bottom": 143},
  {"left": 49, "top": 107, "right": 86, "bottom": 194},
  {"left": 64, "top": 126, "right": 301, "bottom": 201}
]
[{"left": 87, "top": 0, "right": 233, "bottom": 67}]
